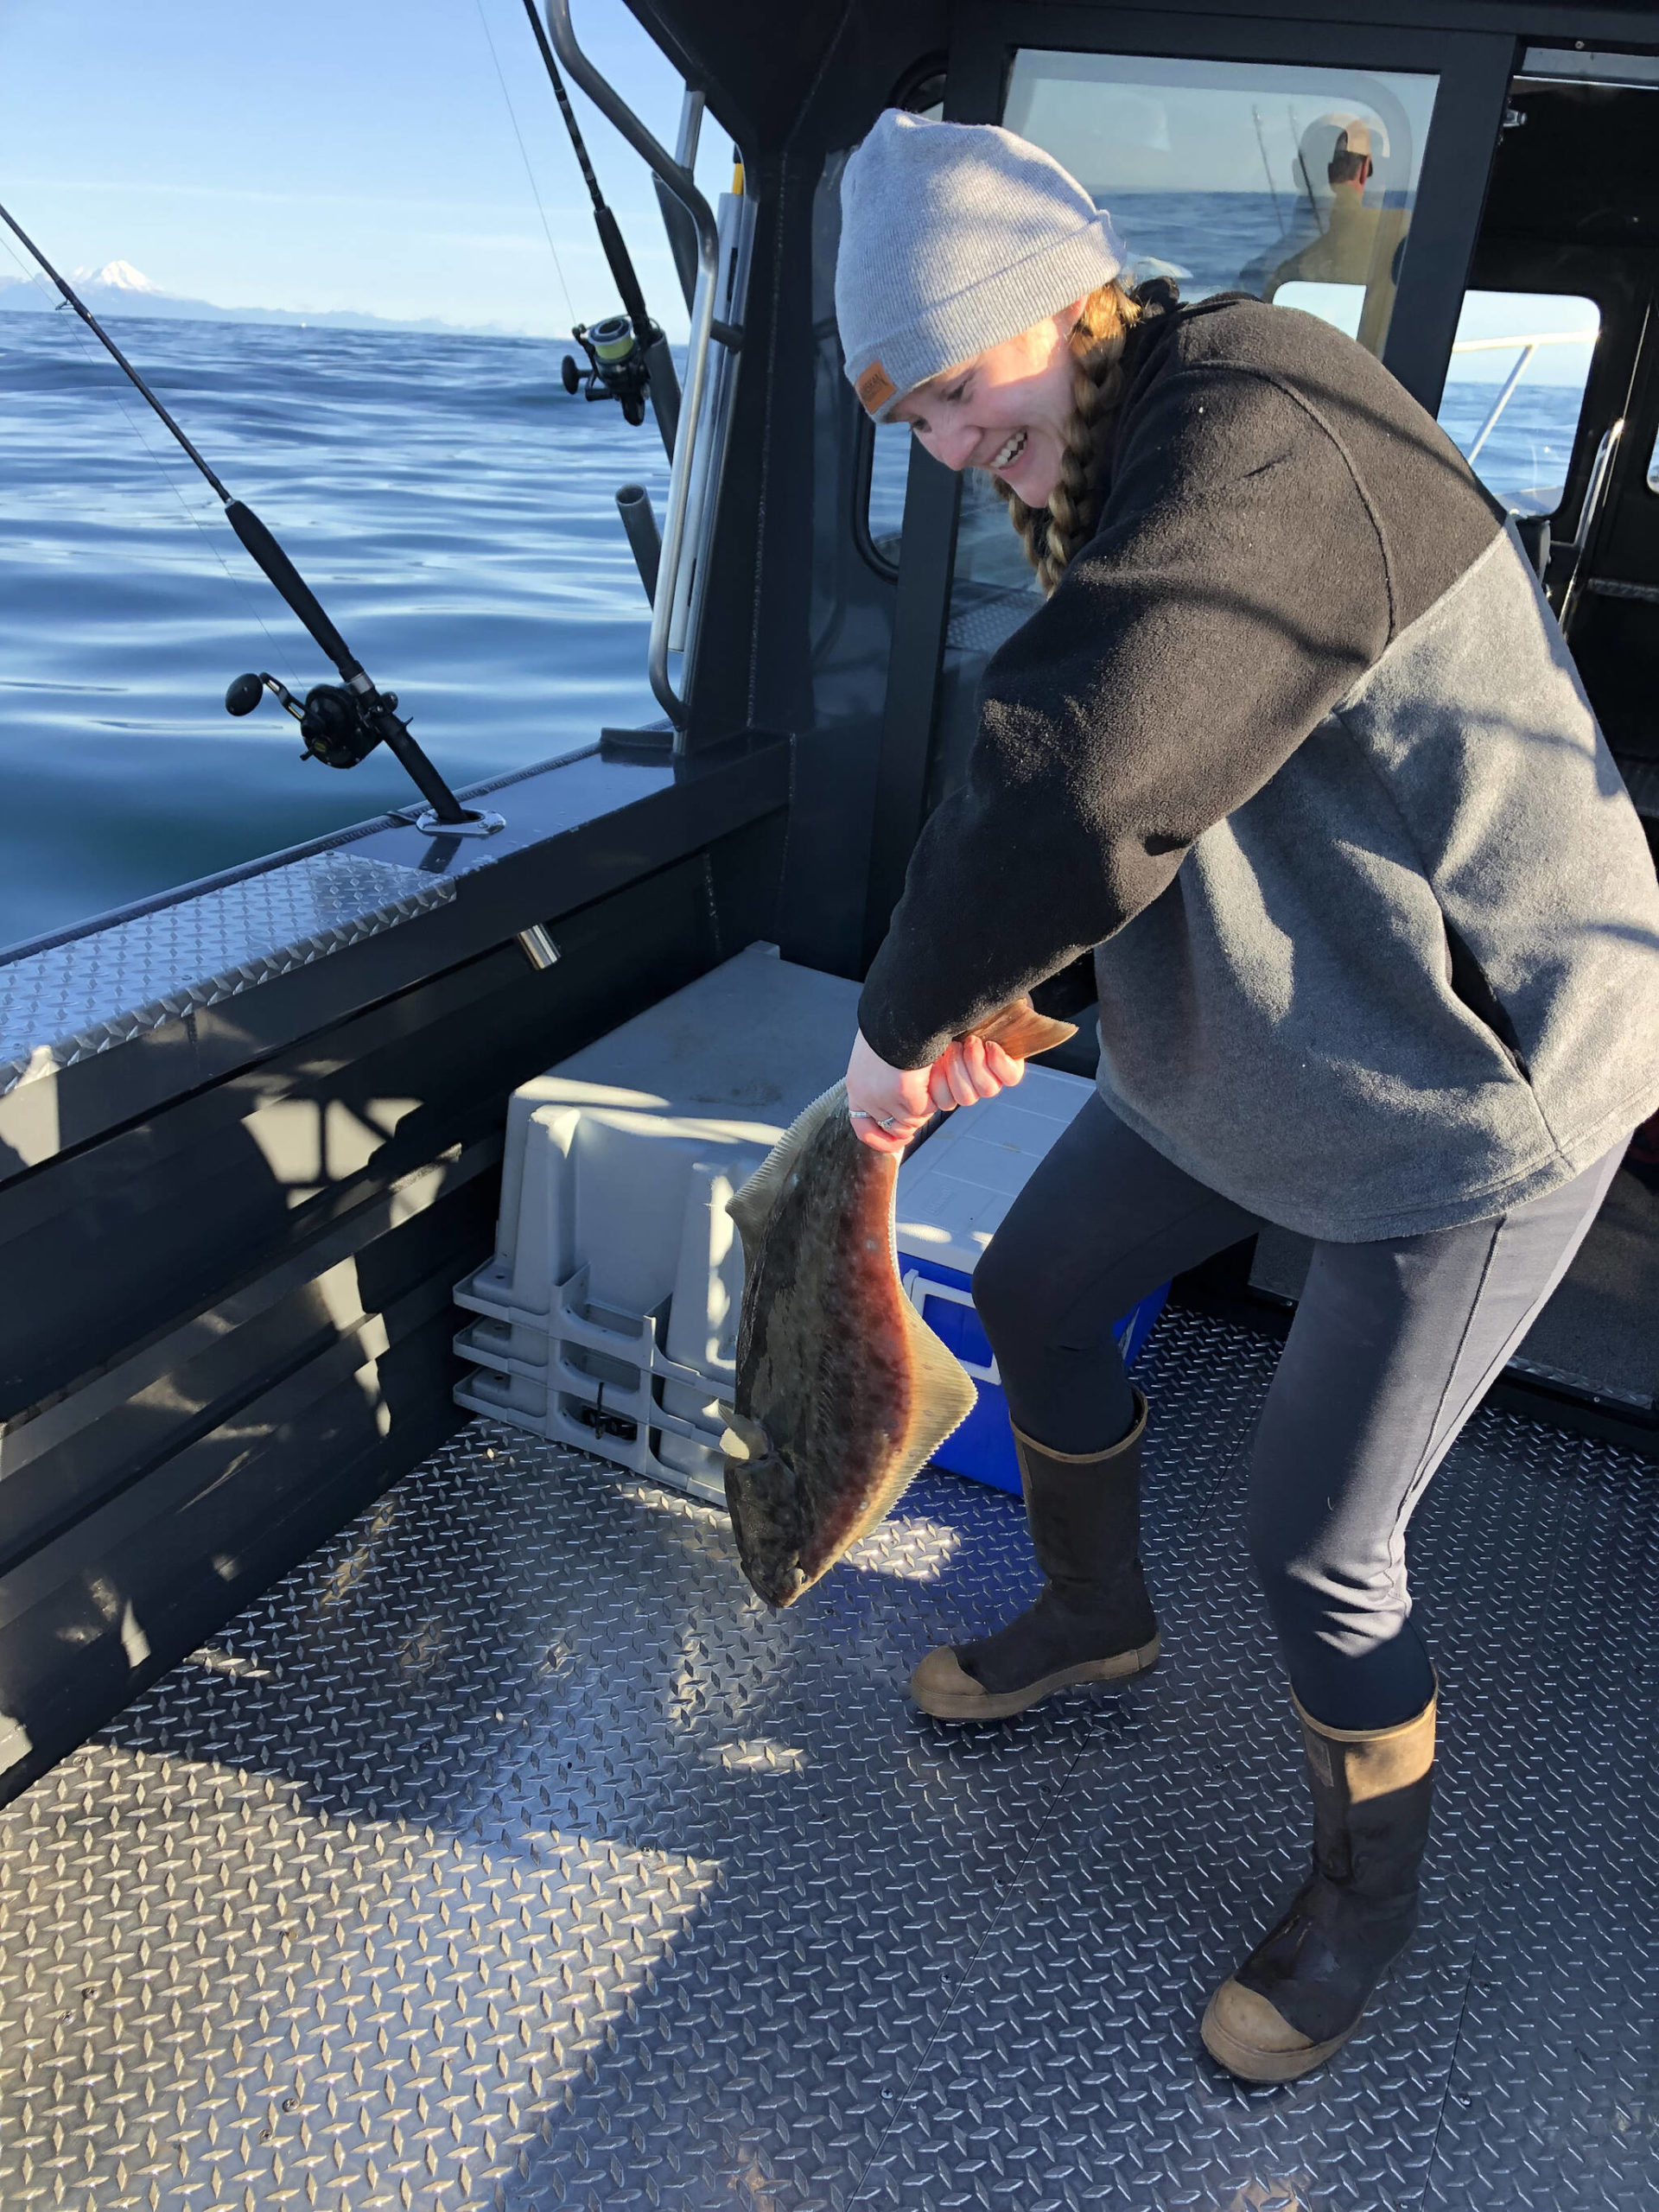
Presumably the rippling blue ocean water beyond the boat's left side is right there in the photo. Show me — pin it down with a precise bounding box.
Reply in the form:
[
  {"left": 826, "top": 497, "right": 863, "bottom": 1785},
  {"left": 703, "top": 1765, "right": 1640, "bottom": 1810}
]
[{"left": 0, "top": 315, "right": 668, "bottom": 944}]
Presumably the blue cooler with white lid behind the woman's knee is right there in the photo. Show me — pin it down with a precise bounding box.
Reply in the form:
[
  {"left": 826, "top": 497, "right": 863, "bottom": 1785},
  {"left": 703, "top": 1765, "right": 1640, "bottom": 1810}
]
[{"left": 898, "top": 1068, "right": 1170, "bottom": 1497}]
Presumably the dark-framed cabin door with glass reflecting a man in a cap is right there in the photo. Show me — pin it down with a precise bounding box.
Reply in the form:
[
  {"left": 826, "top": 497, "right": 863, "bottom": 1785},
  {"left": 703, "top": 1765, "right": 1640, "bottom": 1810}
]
[{"left": 868, "top": 7, "right": 1516, "bottom": 947}]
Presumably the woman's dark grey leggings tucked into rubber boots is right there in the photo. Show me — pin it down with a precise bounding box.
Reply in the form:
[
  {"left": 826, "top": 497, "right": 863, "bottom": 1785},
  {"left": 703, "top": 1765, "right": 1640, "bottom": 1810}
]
[{"left": 973, "top": 1097, "right": 1624, "bottom": 1727}]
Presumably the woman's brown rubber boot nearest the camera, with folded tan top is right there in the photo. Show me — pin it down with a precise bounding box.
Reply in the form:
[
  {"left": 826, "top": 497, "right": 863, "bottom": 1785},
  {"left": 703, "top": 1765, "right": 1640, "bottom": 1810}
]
[{"left": 1201, "top": 1697, "right": 1435, "bottom": 2082}]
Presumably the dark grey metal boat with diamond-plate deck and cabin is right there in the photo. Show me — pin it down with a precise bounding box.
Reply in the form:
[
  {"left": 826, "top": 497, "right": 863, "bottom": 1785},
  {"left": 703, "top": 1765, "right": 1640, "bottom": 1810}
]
[{"left": 0, "top": 0, "right": 1659, "bottom": 2212}]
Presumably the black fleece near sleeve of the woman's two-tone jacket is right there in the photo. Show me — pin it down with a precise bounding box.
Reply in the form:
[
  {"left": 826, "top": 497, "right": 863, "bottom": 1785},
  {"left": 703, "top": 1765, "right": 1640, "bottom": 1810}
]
[{"left": 858, "top": 365, "right": 1391, "bottom": 1068}]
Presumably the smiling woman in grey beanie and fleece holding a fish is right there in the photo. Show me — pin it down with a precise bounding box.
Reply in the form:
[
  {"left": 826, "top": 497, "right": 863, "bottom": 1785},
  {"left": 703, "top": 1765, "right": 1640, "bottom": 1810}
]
[{"left": 836, "top": 111, "right": 1659, "bottom": 2082}]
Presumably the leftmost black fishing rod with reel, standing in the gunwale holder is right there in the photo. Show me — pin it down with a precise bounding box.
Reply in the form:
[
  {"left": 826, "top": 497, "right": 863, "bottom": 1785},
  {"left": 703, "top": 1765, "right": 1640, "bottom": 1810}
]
[{"left": 0, "top": 208, "right": 484, "bottom": 834}]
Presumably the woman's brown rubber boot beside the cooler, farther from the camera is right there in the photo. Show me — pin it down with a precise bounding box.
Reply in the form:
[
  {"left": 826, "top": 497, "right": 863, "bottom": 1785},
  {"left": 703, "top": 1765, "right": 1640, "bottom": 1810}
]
[{"left": 909, "top": 1391, "right": 1157, "bottom": 1721}]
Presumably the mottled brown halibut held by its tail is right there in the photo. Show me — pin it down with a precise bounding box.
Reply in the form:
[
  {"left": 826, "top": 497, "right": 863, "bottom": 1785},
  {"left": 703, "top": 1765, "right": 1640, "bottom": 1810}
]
[{"left": 721, "top": 1002, "right": 1075, "bottom": 1606}]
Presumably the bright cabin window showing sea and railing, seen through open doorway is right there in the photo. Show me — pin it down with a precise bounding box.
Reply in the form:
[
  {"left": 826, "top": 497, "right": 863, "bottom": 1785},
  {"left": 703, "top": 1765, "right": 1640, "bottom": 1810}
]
[{"left": 1440, "top": 292, "right": 1601, "bottom": 515}]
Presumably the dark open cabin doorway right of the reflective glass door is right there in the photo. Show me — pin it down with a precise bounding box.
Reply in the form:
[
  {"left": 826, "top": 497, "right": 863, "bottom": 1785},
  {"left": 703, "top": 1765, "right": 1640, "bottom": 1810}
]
[{"left": 1249, "top": 48, "right": 1659, "bottom": 1422}]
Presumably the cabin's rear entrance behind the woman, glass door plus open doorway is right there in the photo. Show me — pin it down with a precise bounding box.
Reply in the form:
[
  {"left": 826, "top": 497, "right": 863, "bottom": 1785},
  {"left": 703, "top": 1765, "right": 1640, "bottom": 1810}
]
[{"left": 865, "top": 9, "right": 1659, "bottom": 1427}]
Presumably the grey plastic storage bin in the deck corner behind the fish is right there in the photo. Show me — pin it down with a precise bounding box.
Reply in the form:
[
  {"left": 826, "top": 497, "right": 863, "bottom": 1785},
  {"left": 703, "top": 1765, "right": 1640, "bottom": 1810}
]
[{"left": 455, "top": 944, "right": 858, "bottom": 1502}]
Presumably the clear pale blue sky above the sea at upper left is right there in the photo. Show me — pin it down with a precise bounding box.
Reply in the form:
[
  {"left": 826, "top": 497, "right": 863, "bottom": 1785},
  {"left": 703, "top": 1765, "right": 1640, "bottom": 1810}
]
[{"left": 0, "top": 0, "right": 730, "bottom": 336}]
